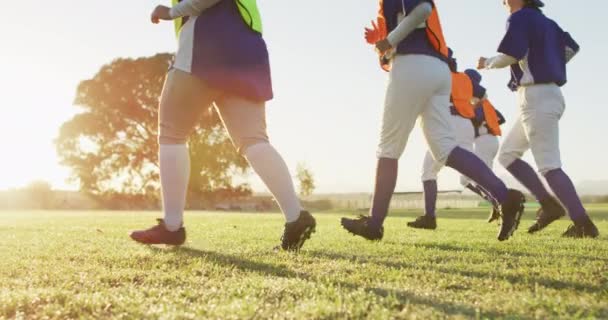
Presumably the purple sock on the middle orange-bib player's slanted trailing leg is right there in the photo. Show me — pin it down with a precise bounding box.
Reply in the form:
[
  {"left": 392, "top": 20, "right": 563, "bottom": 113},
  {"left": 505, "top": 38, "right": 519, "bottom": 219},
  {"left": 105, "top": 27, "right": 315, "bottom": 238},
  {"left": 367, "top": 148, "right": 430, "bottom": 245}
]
[{"left": 446, "top": 147, "right": 508, "bottom": 203}]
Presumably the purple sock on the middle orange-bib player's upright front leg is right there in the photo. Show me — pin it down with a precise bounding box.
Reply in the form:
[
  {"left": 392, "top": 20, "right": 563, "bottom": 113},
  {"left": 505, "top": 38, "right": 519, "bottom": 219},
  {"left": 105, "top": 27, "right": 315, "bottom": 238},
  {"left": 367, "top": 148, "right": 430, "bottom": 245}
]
[{"left": 370, "top": 158, "right": 399, "bottom": 227}]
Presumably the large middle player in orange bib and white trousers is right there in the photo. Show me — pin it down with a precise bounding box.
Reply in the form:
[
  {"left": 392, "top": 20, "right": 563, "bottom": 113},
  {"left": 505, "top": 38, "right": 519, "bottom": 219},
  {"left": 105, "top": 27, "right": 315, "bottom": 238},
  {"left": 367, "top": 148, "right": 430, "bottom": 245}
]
[{"left": 342, "top": 0, "right": 525, "bottom": 241}]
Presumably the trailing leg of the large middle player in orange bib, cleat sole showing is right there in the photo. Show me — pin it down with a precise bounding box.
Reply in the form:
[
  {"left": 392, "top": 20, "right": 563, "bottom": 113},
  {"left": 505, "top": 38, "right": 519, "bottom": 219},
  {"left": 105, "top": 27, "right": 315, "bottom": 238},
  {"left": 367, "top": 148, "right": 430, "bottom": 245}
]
[{"left": 422, "top": 73, "right": 525, "bottom": 241}]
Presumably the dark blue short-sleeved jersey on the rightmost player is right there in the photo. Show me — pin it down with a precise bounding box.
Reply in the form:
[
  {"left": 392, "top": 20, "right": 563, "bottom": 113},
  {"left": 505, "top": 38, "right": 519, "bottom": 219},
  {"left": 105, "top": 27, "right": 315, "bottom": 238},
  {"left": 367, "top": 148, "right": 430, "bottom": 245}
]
[{"left": 498, "top": 8, "right": 579, "bottom": 89}]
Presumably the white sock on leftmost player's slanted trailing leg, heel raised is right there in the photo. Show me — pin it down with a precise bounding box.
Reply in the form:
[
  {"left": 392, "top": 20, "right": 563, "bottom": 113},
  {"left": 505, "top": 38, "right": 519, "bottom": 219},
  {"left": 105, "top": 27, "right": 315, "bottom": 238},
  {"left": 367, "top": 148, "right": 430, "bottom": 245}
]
[{"left": 245, "top": 143, "right": 302, "bottom": 222}]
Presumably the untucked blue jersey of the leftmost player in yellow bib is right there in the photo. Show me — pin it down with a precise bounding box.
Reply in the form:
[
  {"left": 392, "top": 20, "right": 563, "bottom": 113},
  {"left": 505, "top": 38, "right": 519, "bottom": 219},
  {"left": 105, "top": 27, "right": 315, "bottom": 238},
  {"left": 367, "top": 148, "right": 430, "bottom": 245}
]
[{"left": 192, "top": 1, "right": 273, "bottom": 101}]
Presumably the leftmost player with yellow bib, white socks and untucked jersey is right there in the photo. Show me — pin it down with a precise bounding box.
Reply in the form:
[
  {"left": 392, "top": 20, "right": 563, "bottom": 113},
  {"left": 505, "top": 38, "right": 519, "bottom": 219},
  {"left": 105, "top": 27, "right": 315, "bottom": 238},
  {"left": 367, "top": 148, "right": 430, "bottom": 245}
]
[{"left": 131, "top": 0, "right": 316, "bottom": 251}]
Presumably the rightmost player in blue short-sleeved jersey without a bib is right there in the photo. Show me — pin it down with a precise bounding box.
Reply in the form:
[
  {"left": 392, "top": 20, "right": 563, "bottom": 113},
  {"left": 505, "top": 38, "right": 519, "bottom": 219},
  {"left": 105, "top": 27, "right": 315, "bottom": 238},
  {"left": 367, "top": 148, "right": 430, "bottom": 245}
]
[{"left": 478, "top": 0, "right": 599, "bottom": 238}]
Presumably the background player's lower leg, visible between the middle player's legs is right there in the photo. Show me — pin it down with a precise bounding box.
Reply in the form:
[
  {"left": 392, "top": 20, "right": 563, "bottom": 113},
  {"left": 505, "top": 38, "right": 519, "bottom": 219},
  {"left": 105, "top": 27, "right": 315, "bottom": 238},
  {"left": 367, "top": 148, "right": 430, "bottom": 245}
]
[{"left": 407, "top": 151, "right": 443, "bottom": 230}]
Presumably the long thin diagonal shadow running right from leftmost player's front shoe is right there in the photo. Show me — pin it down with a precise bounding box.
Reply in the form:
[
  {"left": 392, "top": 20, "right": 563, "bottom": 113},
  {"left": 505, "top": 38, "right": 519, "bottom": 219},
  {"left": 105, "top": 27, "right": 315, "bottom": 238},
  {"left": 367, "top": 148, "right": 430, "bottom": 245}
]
[{"left": 150, "top": 247, "right": 531, "bottom": 319}]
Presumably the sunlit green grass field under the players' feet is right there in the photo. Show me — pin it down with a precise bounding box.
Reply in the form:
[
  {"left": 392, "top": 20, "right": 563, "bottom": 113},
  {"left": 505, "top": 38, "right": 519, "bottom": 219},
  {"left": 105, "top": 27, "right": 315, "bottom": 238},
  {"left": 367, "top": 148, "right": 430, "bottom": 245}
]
[{"left": 0, "top": 206, "right": 608, "bottom": 319}]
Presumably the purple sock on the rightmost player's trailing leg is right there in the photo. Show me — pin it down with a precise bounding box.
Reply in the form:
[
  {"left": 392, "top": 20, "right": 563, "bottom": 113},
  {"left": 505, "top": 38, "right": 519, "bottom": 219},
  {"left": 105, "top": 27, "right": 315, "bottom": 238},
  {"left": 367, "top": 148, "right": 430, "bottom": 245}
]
[{"left": 545, "top": 169, "right": 587, "bottom": 221}]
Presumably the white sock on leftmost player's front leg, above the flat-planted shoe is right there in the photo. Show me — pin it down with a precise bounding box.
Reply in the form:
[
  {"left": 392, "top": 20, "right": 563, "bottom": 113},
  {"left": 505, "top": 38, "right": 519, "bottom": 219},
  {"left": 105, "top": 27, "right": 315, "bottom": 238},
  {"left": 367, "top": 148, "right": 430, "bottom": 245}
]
[{"left": 159, "top": 144, "right": 190, "bottom": 232}]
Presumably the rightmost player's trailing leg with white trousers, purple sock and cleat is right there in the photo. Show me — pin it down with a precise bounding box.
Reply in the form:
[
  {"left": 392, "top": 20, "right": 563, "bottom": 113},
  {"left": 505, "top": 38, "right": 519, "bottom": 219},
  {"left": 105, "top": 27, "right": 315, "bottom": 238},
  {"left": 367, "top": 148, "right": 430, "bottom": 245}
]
[{"left": 521, "top": 85, "right": 599, "bottom": 237}]
